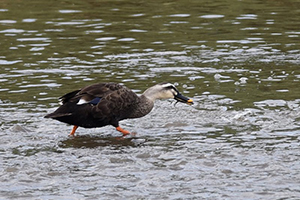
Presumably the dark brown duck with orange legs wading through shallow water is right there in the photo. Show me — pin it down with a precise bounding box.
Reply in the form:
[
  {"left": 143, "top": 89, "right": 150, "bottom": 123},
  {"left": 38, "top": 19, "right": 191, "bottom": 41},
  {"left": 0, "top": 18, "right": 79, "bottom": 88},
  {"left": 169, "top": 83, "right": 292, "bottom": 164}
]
[{"left": 45, "top": 82, "right": 193, "bottom": 137}]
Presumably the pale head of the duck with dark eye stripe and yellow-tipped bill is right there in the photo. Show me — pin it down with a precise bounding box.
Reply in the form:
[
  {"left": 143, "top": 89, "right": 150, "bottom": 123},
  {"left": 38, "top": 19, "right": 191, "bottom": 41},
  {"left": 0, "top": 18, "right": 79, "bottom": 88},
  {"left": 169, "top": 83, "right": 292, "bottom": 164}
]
[{"left": 144, "top": 83, "right": 193, "bottom": 105}]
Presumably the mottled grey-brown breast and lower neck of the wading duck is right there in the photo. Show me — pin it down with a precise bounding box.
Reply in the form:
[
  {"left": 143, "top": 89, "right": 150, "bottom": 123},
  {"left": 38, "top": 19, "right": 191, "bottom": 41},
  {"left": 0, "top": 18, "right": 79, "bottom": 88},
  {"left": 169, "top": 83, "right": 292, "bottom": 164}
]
[{"left": 130, "top": 94, "right": 154, "bottom": 118}]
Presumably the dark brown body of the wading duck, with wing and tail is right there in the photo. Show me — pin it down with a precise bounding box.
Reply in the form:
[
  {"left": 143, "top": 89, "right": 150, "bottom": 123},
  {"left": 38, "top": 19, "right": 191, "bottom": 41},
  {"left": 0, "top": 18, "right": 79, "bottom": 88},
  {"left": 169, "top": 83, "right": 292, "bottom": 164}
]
[{"left": 46, "top": 83, "right": 139, "bottom": 128}]
